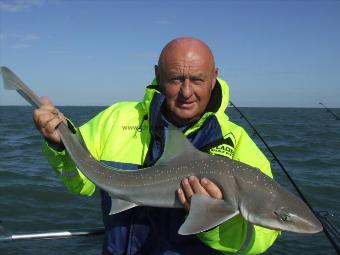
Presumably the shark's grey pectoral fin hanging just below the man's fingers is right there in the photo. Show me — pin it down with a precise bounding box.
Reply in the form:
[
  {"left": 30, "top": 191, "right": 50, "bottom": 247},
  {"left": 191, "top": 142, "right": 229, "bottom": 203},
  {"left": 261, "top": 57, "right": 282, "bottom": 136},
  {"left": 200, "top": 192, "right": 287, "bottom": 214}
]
[{"left": 178, "top": 194, "right": 239, "bottom": 235}]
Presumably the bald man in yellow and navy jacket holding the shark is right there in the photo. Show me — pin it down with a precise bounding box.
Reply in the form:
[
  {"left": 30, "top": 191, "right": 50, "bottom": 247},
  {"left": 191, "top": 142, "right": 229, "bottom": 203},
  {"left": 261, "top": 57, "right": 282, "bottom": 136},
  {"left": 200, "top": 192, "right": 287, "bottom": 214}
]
[{"left": 34, "top": 38, "right": 279, "bottom": 254}]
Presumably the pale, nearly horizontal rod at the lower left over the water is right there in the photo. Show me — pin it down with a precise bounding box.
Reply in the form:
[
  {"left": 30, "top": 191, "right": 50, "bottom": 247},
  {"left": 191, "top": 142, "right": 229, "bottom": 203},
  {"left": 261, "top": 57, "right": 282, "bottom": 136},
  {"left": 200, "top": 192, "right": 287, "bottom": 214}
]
[{"left": 0, "top": 228, "right": 104, "bottom": 242}]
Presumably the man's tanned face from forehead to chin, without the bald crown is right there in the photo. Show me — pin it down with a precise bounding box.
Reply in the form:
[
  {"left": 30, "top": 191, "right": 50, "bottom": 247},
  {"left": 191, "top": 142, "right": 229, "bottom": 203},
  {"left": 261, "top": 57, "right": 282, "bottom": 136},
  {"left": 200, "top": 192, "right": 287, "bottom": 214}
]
[{"left": 156, "top": 51, "right": 217, "bottom": 125}]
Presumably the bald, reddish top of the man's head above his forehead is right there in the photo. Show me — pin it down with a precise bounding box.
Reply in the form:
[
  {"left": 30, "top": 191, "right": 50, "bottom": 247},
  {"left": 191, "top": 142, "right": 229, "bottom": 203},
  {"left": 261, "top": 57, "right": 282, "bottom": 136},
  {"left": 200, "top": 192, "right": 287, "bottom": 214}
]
[{"left": 158, "top": 37, "right": 215, "bottom": 70}]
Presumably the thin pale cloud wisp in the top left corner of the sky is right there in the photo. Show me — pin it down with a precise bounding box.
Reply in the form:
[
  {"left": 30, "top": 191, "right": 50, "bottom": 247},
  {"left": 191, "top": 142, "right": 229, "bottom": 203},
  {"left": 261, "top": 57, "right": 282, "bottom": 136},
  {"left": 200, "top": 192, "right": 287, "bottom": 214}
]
[{"left": 0, "top": 0, "right": 56, "bottom": 12}]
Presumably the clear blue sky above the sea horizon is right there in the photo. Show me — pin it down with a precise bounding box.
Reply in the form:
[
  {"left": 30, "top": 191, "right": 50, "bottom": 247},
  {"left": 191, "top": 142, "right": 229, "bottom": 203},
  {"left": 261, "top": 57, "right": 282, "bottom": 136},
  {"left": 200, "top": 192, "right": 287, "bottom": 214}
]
[{"left": 0, "top": 0, "right": 340, "bottom": 107}]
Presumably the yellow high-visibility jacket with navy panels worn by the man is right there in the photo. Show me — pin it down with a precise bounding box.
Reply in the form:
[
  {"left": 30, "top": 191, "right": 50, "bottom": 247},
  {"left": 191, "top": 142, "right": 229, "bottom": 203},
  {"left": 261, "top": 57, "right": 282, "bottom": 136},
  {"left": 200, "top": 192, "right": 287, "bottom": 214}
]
[{"left": 43, "top": 78, "right": 280, "bottom": 254}]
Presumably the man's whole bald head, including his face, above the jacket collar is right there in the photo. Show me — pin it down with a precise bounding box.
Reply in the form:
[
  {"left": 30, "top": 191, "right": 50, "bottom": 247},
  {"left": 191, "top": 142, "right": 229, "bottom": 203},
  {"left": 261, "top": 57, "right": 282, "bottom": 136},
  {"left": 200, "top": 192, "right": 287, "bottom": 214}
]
[{"left": 155, "top": 37, "right": 217, "bottom": 125}]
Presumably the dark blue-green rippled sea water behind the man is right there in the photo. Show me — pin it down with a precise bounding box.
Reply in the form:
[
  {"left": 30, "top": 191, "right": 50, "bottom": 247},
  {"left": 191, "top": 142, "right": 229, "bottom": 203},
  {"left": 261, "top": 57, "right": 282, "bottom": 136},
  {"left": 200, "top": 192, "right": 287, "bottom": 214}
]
[{"left": 0, "top": 106, "right": 340, "bottom": 255}]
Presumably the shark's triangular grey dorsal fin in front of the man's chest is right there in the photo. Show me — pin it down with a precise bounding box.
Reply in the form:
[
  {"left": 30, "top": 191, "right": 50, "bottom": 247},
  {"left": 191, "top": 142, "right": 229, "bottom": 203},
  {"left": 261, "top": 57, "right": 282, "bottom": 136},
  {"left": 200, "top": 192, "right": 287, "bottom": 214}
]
[{"left": 156, "top": 123, "right": 209, "bottom": 165}]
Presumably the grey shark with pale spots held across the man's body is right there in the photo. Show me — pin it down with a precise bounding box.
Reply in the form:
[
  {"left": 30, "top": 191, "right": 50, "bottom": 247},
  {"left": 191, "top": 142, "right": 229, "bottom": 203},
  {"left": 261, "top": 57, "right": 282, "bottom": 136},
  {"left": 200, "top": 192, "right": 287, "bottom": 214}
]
[{"left": 1, "top": 67, "right": 323, "bottom": 235}]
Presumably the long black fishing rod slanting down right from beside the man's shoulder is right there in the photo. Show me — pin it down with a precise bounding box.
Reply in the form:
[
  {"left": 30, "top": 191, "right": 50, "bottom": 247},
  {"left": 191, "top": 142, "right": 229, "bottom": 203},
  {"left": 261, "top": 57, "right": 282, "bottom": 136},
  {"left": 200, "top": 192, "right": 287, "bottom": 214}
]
[{"left": 229, "top": 101, "right": 340, "bottom": 254}]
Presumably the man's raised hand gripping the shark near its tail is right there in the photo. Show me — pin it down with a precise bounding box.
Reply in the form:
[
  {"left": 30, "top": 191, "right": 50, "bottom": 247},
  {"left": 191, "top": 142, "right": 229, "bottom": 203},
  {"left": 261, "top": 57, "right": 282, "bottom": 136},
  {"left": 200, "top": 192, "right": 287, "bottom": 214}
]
[{"left": 33, "top": 97, "right": 67, "bottom": 147}]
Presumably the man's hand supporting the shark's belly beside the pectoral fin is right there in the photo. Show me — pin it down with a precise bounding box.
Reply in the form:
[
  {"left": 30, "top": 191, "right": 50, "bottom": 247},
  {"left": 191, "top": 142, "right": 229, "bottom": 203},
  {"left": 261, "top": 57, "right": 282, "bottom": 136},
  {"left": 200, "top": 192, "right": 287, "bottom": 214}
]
[{"left": 177, "top": 176, "right": 223, "bottom": 211}]
